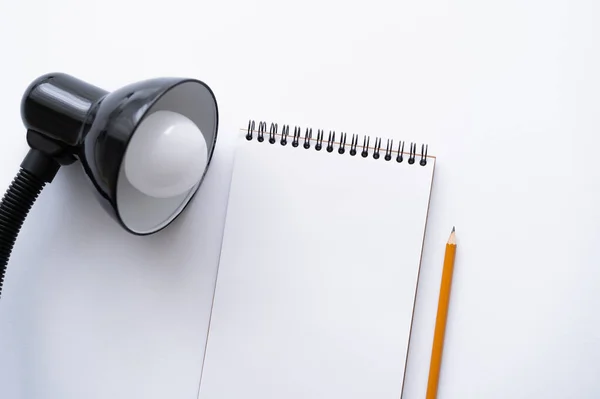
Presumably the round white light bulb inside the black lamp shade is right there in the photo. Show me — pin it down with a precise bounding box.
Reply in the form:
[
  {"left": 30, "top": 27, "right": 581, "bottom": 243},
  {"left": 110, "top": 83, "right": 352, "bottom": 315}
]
[{"left": 124, "top": 111, "right": 208, "bottom": 198}]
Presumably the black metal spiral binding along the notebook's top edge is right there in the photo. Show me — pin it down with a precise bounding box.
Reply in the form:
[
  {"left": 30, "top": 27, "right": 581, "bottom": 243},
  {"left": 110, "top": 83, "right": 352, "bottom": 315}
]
[{"left": 245, "top": 120, "right": 429, "bottom": 166}]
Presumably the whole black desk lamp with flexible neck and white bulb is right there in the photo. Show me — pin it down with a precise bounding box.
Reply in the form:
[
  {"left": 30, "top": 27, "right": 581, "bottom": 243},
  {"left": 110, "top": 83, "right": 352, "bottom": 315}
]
[{"left": 0, "top": 73, "right": 218, "bottom": 294}]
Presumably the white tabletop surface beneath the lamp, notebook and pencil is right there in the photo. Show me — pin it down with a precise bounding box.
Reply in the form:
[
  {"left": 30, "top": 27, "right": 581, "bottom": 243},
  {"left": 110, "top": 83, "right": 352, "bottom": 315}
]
[{"left": 0, "top": 0, "right": 600, "bottom": 399}]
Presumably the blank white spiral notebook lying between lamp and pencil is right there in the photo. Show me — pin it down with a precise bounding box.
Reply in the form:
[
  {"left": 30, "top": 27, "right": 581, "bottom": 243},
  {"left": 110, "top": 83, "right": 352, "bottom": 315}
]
[{"left": 199, "top": 122, "right": 435, "bottom": 399}]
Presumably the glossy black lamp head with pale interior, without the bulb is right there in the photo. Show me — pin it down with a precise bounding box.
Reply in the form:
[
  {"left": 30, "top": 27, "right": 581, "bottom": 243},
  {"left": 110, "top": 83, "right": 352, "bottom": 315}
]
[{"left": 21, "top": 73, "right": 218, "bottom": 235}]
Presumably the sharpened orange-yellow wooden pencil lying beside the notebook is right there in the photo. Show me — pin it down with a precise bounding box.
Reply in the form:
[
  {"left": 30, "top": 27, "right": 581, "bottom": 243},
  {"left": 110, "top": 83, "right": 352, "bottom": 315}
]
[{"left": 426, "top": 227, "right": 456, "bottom": 399}]
